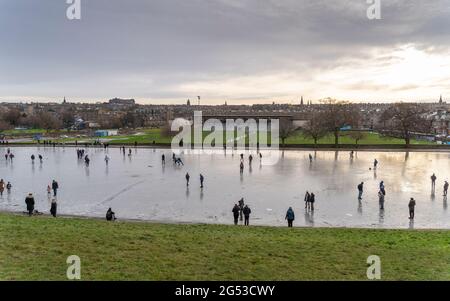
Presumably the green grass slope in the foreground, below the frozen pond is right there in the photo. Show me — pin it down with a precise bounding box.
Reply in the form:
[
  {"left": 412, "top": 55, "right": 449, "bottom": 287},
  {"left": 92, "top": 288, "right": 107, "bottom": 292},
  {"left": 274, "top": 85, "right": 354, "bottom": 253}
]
[{"left": 0, "top": 213, "right": 450, "bottom": 280}]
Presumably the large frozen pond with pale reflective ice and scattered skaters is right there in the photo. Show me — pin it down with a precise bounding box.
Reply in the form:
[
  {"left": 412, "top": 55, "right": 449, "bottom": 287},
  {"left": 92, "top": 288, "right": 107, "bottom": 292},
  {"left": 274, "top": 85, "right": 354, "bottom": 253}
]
[{"left": 0, "top": 147, "right": 450, "bottom": 229}]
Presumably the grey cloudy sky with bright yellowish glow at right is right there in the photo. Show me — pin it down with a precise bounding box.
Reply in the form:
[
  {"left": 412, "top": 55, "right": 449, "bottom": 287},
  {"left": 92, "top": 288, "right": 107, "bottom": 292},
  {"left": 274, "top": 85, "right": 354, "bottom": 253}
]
[{"left": 0, "top": 0, "right": 450, "bottom": 104}]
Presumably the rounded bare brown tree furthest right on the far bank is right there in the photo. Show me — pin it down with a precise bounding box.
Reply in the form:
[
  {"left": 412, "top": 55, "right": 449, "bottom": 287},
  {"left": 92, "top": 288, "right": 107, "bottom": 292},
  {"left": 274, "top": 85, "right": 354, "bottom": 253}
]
[{"left": 381, "top": 103, "right": 432, "bottom": 147}]
